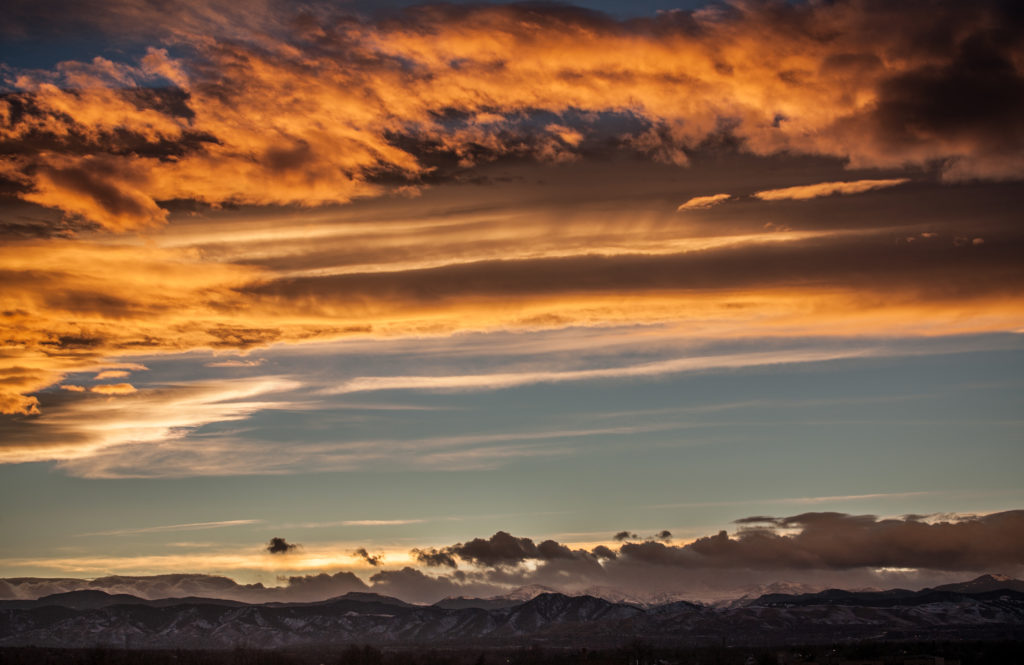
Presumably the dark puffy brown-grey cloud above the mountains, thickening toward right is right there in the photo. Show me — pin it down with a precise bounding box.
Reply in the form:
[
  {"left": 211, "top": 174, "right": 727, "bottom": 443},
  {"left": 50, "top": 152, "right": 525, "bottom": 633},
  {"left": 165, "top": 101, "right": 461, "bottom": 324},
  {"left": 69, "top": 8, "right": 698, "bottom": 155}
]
[{"left": 382, "top": 510, "right": 1024, "bottom": 598}]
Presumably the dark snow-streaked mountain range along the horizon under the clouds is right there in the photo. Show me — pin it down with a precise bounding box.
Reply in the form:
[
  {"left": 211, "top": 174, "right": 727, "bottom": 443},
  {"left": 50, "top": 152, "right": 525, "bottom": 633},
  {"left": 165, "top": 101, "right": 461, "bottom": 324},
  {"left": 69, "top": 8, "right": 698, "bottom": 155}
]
[{"left": 0, "top": 589, "right": 1024, "bottom": 649}]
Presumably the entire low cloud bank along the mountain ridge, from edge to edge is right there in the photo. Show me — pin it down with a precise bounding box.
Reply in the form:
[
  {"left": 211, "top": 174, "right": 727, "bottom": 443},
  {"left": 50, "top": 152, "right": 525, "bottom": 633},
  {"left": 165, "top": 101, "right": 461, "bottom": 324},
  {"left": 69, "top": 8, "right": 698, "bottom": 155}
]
[{"left": 0, "top": 510, "right": 1024, "bottom": 602}]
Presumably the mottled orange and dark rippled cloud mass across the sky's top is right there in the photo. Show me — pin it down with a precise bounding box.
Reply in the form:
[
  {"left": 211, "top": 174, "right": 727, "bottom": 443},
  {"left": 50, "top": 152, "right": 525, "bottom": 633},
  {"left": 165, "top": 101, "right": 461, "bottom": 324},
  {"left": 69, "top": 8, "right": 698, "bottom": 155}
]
[{"left": 0, "top": 1, "right": 1024, "bottom": 231}]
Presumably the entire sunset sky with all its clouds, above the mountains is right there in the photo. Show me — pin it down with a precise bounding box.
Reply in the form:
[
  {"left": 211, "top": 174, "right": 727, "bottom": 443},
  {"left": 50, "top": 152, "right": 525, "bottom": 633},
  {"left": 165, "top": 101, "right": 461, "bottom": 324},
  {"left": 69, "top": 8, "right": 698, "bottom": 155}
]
[{"left": 0, "top": 0, "right": 1024, "bottom": 602}]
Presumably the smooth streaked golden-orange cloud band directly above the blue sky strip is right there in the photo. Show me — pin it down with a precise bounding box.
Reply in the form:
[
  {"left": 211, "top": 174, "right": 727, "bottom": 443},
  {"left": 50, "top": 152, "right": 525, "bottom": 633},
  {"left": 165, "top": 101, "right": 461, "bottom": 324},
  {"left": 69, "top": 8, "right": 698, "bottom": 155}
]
[{"left": 0, "top": 218, "right": 1024, "bottom": 414}]
